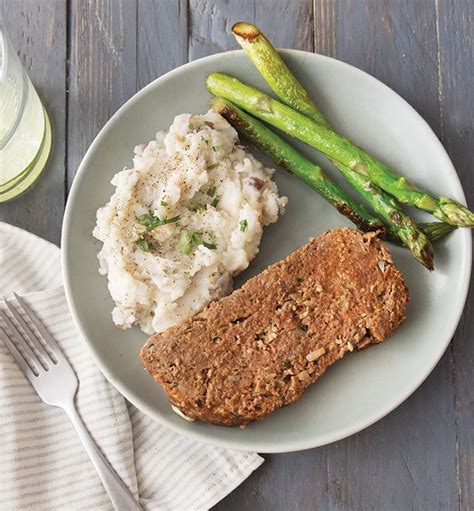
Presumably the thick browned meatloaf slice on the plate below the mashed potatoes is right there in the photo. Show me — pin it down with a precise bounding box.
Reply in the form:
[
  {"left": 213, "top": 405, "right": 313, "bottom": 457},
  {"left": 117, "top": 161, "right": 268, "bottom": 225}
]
[{"left": 141, "top": 228, "right": 408, "bottom": 426}]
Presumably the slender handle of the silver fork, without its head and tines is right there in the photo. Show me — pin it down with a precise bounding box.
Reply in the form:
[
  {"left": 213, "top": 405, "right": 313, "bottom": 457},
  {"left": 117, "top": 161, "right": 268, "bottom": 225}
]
[{"left": 64, "top": 405, "right": 143, "bottom": 511}]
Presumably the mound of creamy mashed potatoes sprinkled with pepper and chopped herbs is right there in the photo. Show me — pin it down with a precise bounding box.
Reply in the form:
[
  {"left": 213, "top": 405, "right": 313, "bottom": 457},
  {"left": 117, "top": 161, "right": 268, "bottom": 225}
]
[{"left": 93, "top": 111, "right": 286, "bottom": 334}]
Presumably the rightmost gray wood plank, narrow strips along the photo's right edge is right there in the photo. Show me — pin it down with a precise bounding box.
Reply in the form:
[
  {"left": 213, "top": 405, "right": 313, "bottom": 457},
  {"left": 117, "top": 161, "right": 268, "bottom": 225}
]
[{"left": 437, "top": 0, "right": 474, "bottom": 510}]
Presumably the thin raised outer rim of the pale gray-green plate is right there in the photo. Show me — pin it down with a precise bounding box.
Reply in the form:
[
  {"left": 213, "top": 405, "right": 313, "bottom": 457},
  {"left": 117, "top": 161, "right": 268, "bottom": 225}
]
[{"left": 61, "top": 49, "right": 472, "bottom": 453}]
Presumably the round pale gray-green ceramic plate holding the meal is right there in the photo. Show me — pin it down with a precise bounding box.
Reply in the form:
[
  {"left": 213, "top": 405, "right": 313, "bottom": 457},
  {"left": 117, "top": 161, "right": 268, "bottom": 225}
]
[{"left": 62, "top": 50, "right": 471, "bottom": 452}]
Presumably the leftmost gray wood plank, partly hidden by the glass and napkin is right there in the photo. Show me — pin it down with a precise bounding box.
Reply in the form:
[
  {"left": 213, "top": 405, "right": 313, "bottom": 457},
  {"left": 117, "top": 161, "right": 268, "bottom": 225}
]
[{"left": 0, "top": 0, "right": 66, "bottom": 243}]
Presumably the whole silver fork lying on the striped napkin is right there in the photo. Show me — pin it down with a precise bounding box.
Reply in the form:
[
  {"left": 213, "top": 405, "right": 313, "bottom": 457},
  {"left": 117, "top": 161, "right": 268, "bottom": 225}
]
[{"left": 0, "top": 293, "right": 142, "bottom": 511}]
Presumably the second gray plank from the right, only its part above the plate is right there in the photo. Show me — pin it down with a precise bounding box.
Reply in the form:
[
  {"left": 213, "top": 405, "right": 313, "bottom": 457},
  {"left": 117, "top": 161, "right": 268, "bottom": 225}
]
[{"left": 314, "top": 0, "right": 439, "bottom": 133}]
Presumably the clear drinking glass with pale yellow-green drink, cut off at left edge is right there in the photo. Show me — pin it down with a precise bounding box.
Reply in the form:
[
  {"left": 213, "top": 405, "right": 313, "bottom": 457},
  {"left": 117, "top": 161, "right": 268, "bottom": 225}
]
[{"left": 0, "top": 23, "right": 51, "bottom": 203}]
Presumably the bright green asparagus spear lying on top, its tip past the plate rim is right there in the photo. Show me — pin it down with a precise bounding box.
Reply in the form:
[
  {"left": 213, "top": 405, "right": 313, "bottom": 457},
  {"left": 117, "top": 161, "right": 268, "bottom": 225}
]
[{"left": 206, "top": 73, "right": 474, "bottom": 227}]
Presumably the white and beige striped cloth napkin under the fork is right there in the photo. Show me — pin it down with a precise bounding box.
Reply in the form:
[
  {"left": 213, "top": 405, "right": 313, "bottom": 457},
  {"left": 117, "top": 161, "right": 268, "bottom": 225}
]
[{"left": 0, "top": 223, "right": 263, "bottom": 511}]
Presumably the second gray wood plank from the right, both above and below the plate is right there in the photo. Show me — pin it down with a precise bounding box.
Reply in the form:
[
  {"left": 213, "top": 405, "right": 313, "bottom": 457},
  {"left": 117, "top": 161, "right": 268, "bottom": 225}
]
[{"left": 315, "top": 0, "right": 458, "bottom": 510}]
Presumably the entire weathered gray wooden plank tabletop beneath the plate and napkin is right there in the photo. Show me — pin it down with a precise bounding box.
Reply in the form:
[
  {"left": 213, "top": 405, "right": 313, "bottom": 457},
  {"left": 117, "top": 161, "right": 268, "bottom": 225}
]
[{"left": 0, "top": 0, "right": 474, "bottom": 511}]
